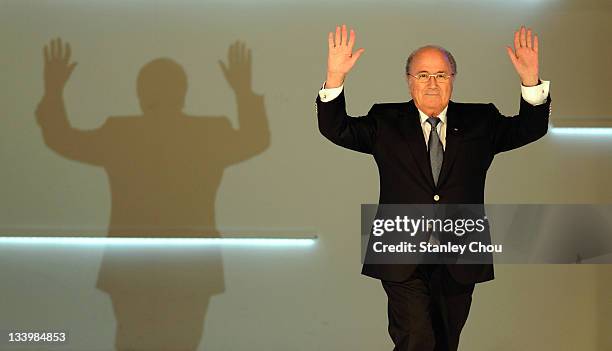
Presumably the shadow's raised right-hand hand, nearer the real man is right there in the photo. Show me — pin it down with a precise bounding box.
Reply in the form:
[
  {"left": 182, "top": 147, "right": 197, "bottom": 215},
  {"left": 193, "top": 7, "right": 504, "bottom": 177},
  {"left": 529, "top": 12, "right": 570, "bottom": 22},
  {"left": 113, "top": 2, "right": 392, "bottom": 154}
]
[{"left": 219, "top": 41, "right": 251, "bottom": 93}]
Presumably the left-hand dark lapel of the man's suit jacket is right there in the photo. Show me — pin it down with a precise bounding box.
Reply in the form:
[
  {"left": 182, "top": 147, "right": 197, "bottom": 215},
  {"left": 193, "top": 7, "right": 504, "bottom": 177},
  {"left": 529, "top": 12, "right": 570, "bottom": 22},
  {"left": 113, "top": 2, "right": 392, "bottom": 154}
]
[{"left": 399, "top": 101, "right": 435, "bottom": 188}]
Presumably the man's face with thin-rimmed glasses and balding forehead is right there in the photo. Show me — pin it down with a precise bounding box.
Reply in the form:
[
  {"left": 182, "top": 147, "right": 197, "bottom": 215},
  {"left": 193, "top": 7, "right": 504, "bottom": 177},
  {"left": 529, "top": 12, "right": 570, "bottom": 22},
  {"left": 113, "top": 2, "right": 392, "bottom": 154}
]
[{"left": 407, "top": 48, "right": 454, "bottom": 115}]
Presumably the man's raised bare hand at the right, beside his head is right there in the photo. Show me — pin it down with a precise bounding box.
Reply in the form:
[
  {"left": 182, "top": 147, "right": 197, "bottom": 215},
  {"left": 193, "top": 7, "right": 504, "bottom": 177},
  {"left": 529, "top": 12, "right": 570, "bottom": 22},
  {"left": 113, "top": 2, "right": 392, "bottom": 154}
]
[{"left": 506, "top": 26, "right": 539, "bottom": 86}]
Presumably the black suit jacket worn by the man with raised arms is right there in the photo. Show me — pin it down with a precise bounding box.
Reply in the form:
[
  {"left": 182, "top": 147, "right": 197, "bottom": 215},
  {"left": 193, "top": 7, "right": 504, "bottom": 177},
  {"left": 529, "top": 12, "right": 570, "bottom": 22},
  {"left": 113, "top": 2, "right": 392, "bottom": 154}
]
[{"left": 316, "top": 92, "right": 550, "bottom": 283}]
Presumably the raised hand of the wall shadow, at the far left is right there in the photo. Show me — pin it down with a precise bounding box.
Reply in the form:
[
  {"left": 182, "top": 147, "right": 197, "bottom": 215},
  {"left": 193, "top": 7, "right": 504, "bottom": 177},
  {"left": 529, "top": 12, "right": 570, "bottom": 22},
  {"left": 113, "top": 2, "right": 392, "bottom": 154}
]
[{"left": 43, "top": 38, "right": 77, "bottom": 95}]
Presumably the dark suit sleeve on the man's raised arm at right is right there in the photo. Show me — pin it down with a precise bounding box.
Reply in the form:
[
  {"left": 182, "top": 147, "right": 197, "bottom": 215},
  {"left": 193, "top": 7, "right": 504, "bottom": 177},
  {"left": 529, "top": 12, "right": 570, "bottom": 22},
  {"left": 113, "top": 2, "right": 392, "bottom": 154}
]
[{"left": 489, "top": 95, "right": 551, "bottom": 154}]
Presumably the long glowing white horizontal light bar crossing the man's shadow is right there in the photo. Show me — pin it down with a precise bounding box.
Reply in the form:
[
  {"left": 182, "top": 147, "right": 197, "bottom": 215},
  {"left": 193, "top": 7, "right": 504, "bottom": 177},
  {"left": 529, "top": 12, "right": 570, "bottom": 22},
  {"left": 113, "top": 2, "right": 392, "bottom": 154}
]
[{"left": 0, "top": 236, "right": 316, "bottom": 248}]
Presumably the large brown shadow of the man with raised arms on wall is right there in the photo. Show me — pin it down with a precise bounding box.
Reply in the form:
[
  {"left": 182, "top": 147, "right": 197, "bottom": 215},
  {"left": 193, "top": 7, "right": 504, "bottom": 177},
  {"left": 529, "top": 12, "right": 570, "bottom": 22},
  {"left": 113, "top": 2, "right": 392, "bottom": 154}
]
[{"left": 36, "top": 39, "right": 270, "bottom": 350}]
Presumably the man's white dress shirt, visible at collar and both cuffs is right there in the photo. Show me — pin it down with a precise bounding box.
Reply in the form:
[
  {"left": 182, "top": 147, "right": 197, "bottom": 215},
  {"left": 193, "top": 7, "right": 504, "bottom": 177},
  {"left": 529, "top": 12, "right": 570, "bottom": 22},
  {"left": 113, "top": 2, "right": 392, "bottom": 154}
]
[{"left": 319, "top": 80, "right": 550, "bottom": 150}]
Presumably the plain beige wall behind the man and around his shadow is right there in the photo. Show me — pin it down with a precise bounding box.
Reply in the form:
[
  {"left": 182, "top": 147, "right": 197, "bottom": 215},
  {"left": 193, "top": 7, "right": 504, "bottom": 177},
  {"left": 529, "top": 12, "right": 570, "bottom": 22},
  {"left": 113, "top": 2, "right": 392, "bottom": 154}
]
[{"left": 0, "top": 0, "right": 612, "bottom": 351}]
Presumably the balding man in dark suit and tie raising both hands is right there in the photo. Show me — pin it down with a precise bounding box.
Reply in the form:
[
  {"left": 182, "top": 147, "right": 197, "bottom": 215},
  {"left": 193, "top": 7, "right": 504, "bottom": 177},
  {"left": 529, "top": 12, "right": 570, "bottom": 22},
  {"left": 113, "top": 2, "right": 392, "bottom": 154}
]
[{"left": 317, "top": 25, "right": 550, "bottom": 351}]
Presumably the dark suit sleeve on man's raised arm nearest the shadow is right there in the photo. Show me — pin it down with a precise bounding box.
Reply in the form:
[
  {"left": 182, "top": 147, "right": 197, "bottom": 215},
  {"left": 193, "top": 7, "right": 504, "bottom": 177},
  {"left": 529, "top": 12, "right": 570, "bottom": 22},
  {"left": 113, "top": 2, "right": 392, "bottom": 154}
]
[{"left": 316, "top": 91, "right": 378, "bottom": 154}]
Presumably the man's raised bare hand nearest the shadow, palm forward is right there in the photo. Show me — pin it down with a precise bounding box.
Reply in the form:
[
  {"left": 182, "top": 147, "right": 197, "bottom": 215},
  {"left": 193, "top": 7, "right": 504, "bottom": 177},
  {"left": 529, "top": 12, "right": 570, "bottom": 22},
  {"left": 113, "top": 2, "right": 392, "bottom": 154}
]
[{"left": 325, "top": 24, "right": 365, "bottom": 88}]
